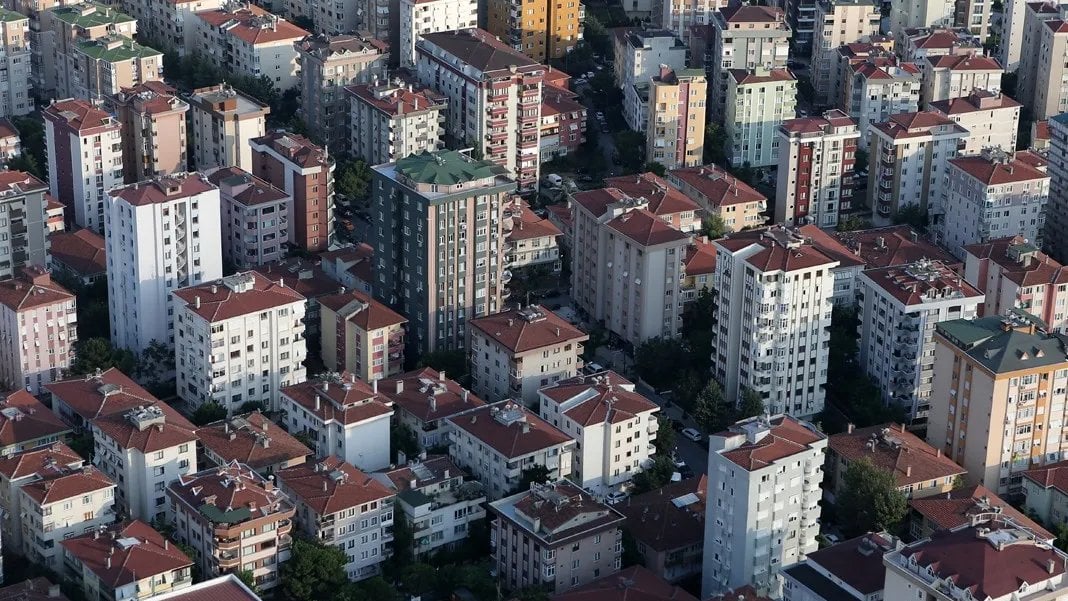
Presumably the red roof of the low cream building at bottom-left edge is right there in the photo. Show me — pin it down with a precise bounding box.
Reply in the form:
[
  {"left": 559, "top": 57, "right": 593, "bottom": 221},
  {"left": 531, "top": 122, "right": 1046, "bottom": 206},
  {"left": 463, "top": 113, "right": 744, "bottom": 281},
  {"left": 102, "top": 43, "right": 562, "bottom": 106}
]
[{"left": 61, "top": 520, "right": 193, "bottom": 592}]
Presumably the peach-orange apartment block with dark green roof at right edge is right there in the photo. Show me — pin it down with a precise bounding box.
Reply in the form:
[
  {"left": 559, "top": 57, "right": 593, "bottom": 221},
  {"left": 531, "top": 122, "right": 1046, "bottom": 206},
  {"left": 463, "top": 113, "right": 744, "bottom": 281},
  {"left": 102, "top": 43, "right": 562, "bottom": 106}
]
[{"left": 927, "top": 313, "right": 1068, "bottom": 494}]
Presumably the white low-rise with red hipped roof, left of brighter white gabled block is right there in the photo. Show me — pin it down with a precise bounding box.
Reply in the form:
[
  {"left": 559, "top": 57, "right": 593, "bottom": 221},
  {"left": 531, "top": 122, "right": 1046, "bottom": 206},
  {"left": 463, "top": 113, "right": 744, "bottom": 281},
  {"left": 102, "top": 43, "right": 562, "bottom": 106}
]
[{"left": 446, "top": 400, "right": 575, "bottom": 500}]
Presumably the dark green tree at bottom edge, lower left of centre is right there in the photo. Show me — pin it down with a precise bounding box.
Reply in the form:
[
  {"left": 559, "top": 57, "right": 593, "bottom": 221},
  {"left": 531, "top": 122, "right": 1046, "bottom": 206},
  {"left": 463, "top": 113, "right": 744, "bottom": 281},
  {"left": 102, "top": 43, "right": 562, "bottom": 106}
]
[{"left": 281, "top": 538, "right": 348, "bottom": 601}]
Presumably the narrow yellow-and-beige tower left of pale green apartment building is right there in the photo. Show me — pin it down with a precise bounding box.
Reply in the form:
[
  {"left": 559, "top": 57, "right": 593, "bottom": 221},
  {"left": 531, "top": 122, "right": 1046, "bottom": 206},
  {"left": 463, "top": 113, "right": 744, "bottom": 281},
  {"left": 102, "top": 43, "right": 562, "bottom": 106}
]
[{"left": 645, "top": 67, "right": 708, "bottom": 169}]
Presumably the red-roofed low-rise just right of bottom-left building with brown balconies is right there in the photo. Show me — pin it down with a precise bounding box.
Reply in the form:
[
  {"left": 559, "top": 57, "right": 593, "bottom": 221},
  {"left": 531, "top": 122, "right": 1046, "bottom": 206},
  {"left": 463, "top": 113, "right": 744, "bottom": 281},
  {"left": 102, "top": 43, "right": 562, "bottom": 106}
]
[{"left": 277, "top": 457, "right": 397, "bottom": 581}]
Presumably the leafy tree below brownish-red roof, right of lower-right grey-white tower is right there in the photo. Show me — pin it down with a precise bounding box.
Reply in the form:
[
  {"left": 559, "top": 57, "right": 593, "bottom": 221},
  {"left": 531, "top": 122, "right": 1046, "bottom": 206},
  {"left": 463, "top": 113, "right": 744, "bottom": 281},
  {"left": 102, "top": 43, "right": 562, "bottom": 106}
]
[{"left": 835, "top": 457, "right": 909, "bottom": 536}]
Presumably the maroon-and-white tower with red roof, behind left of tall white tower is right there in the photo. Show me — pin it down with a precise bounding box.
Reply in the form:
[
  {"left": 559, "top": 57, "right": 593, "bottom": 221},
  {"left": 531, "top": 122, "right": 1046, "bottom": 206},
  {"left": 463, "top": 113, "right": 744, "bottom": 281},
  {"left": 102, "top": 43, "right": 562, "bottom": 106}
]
[{"left": 42, "top": 99, "right": 123, "bottom": 234}]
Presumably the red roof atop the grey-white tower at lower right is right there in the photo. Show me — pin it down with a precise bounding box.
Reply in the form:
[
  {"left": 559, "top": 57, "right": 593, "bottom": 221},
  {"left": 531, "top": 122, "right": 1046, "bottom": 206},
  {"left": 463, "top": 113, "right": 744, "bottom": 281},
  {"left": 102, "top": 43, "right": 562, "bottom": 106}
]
[{"left": 712, "top": 415, "right": 826, "bottom": 472}]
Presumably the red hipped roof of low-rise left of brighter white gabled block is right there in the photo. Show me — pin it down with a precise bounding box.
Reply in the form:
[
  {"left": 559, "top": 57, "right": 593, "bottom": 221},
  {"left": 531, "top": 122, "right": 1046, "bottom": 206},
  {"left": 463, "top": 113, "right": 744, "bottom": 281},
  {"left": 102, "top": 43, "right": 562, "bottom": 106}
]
[{"left": 449, "top": 400, "right": 572, "bottom": 459}]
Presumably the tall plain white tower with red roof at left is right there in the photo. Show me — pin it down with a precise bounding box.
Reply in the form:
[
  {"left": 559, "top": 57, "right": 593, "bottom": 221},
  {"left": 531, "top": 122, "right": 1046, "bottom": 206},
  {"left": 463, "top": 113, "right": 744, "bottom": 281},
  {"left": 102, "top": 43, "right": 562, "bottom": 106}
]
[{"left": 105, "top": 173, "right": 222, "bottom": 352}]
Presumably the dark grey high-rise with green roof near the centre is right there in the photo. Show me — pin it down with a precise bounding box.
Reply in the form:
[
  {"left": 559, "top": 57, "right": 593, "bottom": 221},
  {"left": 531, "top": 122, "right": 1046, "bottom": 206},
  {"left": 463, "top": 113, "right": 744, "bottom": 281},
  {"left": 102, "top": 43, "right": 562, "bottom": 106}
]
[{"left": 371, "top": 149, "right": 516, "bottom": 351}]
